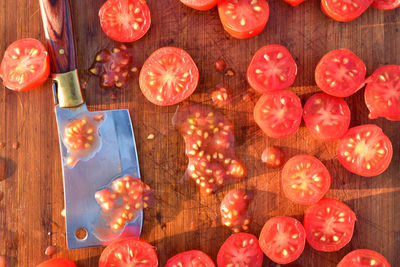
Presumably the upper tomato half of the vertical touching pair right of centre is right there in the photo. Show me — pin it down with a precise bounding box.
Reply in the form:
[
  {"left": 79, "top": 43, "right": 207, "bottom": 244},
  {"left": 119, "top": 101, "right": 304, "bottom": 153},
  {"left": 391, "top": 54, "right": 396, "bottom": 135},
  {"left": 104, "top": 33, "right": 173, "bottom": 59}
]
[{"left": 247, "top": 45, "right": 297, "bottom": 93}]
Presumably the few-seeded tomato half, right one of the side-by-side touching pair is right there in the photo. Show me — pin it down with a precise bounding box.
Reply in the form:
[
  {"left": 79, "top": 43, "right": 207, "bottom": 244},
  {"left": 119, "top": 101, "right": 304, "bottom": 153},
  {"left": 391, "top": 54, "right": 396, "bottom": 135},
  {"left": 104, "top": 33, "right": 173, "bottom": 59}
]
[{"left": 303, "top": 93, "right": 351, "bottom": 141}]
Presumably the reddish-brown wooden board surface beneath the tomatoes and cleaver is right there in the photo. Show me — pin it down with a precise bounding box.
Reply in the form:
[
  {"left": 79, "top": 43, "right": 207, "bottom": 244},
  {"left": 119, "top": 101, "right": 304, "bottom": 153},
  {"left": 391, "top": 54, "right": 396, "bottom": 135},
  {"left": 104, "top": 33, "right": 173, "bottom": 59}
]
[{"left": 0, "top": 0, "right": 400, "bottom": 267}]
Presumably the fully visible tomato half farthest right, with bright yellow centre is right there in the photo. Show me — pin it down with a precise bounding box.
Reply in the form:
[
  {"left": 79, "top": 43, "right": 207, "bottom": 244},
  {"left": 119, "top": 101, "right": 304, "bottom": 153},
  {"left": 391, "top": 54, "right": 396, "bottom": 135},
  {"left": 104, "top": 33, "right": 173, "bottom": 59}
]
[{"left": 337, "top": 124, "right": 393, "bottom": 177}]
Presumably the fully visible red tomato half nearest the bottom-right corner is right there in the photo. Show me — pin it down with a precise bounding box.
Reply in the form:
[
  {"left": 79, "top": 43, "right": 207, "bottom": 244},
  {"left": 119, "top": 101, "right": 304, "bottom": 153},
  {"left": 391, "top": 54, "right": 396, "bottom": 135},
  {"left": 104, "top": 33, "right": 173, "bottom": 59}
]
[{"left": 304, "top": 198, "right": 357, "bottom": 252}]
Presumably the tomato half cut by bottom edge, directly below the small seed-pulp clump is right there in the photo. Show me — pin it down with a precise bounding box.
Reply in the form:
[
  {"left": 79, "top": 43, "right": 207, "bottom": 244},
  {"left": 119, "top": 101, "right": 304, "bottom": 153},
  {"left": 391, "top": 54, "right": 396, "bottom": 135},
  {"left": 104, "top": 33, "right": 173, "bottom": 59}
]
[{"left": 217, "top": 233, "right": 263, "bottom": 267}]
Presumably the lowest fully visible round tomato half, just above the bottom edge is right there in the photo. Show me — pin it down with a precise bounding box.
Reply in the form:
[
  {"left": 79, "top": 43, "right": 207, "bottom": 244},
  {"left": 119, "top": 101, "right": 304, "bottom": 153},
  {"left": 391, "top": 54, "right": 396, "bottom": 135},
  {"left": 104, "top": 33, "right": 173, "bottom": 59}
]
[{"left": 259, "top": 216, "right": 306, "bottom": 264}]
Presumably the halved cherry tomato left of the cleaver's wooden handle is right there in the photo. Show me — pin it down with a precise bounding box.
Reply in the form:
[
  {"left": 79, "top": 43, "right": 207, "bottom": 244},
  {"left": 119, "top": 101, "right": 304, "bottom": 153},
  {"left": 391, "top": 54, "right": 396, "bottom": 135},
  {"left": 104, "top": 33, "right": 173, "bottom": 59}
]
[{"left": 0, "top": 38, "right": 50, "bottom": 91}]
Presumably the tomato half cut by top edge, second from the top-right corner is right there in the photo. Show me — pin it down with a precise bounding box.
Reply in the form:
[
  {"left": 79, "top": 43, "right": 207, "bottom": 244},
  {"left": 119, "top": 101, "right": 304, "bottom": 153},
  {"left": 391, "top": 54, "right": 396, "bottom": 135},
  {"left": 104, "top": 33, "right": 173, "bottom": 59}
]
[{"left": 321, "top": 0, "right": 374, "bottom": 22}]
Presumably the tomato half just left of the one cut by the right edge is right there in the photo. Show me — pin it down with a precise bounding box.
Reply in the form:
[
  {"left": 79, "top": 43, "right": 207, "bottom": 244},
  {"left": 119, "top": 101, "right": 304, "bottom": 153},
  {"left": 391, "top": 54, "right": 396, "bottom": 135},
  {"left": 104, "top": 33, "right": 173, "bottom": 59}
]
[{"left": 315, "top": 49, "right": 366, "bottom": 97}]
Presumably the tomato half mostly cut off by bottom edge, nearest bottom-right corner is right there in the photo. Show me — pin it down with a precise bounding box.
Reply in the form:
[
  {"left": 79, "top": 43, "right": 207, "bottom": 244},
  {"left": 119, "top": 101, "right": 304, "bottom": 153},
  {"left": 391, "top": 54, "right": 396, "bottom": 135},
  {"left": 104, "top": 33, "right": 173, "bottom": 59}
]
[{"left": 337, "top": 249, "right": 390, "bottom": 267}]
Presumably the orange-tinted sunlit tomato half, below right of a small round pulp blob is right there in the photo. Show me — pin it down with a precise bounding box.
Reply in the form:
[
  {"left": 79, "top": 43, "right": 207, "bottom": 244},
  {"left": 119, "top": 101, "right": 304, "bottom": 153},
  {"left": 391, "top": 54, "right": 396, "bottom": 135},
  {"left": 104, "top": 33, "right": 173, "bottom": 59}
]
[{"left": 282, "top": 155, "right": 331, "bottom": 205}]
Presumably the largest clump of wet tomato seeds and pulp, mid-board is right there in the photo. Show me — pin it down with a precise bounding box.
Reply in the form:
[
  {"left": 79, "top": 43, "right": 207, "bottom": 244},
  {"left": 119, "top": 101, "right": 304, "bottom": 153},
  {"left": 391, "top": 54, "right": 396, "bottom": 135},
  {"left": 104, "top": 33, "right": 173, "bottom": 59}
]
[{"left": 172, "top": 104, "right": 246, "bottom": 194}]
